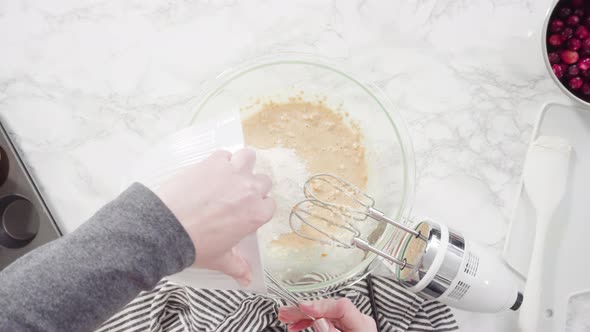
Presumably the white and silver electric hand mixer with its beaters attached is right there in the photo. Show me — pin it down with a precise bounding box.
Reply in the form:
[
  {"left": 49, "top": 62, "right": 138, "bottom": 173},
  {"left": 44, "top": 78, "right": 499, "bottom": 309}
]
[{"left": 289, "top": 174, "right": 523, "bottom": 312}]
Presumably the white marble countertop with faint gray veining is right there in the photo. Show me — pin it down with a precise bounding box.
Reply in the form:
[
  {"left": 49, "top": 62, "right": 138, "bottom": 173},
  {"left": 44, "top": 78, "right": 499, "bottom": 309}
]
[{"left": 0, "top": 0, "right": 580, "bottom": 331}]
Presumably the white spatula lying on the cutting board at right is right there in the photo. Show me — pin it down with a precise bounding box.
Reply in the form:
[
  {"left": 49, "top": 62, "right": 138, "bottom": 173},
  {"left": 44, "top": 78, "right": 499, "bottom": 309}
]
[{"left": 518, "top": 136, "right": 572, "bottom": 332}]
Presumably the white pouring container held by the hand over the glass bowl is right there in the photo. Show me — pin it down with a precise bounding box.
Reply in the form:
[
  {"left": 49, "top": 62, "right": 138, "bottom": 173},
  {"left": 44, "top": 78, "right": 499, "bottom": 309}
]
[{"left": 124, "top": 110, "right": 266, "bottom": 293}]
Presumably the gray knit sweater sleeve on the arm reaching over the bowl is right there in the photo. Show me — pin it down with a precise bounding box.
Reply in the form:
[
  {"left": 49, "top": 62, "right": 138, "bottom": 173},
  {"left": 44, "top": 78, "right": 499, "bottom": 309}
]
[{"left": 0, "top": 184, "right": 195, "bottom": 331}]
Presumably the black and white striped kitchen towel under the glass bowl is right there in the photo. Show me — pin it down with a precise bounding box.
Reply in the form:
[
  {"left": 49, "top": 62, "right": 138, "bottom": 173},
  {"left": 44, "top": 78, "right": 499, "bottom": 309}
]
[{"left": 98, "top": 277, "right": 458, "bottom": 332}]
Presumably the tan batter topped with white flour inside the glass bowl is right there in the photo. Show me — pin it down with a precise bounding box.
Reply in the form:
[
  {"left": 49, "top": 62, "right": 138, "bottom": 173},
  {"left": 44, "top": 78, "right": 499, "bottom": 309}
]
[{"left": 242, "top": 97, "right": 374, "bottom": 282}]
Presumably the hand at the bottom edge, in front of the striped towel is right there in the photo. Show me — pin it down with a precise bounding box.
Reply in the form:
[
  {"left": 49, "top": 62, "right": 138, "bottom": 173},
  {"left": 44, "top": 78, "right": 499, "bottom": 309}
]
[{"left": 279, "top": 298, "right": 377, "bottom": 332}]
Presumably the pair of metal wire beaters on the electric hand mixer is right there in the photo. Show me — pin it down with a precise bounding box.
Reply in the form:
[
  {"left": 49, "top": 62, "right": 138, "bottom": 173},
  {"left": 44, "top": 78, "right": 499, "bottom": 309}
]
[{"left": 289, "top": 174, "right": 427, "bottom": 269}]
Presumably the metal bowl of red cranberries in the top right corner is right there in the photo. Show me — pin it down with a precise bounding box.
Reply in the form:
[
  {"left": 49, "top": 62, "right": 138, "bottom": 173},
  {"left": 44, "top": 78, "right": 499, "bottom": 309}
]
[{"left": 543, "top": 0, "right": 590, "bottom": 106}]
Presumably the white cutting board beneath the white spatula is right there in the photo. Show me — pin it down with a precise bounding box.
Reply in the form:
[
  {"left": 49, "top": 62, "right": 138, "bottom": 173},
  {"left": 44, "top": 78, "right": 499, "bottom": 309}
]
[{"left": 503, "top": 104, "right": 590, "bottom": 332}]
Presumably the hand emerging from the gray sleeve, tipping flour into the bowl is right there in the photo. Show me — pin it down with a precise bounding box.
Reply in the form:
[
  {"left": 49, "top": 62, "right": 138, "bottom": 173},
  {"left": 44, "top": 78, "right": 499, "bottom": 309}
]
[{"left": 155, "top": 149, "right": 276, "bottom": 286}]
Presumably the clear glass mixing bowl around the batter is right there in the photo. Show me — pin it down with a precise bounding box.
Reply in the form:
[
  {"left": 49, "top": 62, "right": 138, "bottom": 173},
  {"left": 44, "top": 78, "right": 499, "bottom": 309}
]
[{"left": 192, "top": 54, "right": 415, "bottom": 296}]
